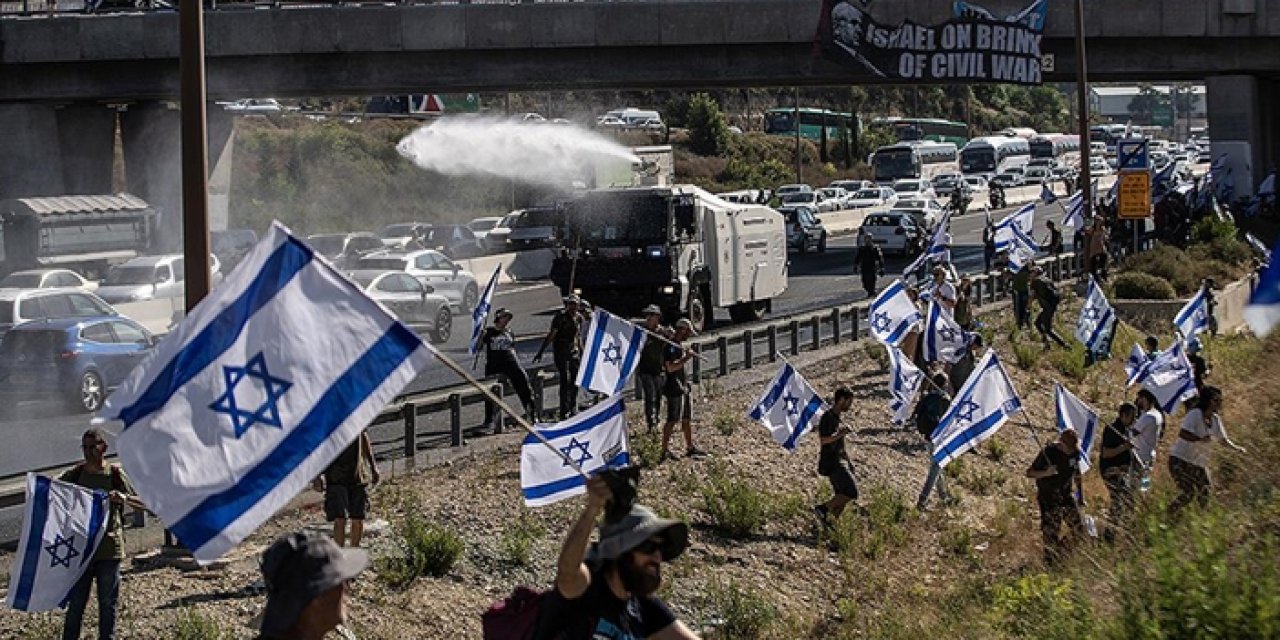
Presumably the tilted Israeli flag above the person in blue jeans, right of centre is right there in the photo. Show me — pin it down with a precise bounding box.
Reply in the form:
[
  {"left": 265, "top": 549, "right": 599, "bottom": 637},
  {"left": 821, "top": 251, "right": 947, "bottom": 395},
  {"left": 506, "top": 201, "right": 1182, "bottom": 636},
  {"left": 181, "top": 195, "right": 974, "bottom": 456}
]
[{"left": 931, "top": 349, "right": 1023, "bottom": 467}]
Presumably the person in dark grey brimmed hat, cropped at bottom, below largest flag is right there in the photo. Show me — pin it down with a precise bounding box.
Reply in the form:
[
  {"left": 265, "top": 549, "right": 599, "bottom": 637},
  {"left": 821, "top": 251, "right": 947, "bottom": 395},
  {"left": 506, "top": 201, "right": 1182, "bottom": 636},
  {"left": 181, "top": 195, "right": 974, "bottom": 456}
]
[{"left": 257, "top": 532, "right": 369, "bottom": 640}]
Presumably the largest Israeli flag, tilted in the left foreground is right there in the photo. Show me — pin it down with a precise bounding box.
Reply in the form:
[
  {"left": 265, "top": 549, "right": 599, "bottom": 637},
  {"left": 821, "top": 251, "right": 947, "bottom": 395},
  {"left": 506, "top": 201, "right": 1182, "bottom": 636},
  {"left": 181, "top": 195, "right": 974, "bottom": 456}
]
[{"left": 102, "top": 223, "right": 433, "bottom": 563}]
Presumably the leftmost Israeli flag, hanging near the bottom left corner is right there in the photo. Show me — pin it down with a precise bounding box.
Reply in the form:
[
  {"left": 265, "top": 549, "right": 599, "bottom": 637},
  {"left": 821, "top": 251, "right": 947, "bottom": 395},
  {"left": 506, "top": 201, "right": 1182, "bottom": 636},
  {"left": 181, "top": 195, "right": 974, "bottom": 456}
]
[{"left": 5, "top": 474, "right": 110, "bottom": 612}]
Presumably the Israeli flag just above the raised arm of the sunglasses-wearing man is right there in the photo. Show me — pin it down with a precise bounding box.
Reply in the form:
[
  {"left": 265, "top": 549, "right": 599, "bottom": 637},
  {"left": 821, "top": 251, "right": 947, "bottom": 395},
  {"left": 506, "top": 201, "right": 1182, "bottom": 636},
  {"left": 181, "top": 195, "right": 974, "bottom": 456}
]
[{"left": 520, "top": 396, "right": 631, "bottom": 507}]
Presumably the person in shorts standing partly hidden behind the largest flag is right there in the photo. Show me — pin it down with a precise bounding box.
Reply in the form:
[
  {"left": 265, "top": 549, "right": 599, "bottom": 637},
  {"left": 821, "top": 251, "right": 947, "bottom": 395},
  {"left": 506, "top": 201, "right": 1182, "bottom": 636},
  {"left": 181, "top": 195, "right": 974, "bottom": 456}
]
[{"left": 312, "top": 431, "right": 383, "bottom": 547}]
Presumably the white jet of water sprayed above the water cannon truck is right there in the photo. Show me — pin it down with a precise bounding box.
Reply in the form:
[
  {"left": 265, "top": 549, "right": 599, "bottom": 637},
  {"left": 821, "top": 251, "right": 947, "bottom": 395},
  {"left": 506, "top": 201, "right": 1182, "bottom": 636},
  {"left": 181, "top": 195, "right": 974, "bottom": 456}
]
[{"left": 396, "top": 116, "right": 640, "bottom": 187}]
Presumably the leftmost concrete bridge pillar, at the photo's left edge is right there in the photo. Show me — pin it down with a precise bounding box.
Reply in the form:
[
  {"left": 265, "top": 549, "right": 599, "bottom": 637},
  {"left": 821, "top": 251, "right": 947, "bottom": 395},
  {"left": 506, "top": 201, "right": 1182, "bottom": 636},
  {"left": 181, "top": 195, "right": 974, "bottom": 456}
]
[{"left": 0, "top": 102, "right": 65, "bottom": 198}]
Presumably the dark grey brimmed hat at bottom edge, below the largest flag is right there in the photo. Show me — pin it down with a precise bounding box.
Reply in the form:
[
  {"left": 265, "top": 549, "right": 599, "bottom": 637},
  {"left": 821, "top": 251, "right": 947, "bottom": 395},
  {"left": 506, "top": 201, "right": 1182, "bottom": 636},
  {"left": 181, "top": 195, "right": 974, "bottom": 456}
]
[{"left": 254, "top": 531, "right": 369, "bottom": 634}]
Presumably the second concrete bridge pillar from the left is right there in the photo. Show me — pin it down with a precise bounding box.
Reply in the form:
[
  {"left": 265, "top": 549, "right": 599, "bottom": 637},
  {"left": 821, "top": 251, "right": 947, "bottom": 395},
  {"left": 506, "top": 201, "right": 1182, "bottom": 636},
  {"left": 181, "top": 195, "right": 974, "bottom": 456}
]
[{"left": 51, "top": 104, "right": 115, "bottom": 195}]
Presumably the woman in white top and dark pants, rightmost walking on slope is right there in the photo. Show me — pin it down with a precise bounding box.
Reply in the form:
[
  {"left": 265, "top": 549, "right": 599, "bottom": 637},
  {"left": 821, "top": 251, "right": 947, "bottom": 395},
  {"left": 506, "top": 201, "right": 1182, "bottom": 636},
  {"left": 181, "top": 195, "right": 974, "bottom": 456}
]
[{"left": 1169, "top": 387, "right": 1244, "bottom": 513}]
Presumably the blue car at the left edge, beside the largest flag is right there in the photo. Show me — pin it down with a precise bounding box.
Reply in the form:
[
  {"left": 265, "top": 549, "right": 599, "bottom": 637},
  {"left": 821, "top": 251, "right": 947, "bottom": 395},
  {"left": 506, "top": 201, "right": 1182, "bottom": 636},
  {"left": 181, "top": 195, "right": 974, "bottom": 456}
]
[{"left": 0, "top": 316, "right": 156, "bottom": 413}]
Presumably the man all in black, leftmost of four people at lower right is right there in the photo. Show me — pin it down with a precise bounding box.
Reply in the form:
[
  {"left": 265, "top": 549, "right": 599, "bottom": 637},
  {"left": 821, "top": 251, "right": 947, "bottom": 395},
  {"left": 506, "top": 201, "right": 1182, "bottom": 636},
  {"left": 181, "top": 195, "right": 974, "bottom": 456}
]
[{"left": 1027, "top": 429, "right": 1084, "bottom": 564}]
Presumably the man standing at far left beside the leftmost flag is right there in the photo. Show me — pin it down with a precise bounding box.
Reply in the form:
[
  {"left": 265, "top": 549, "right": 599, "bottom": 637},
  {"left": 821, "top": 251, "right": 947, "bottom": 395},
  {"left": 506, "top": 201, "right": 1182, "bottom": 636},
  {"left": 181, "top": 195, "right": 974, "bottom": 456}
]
[{"left": 58, "top": 429, "right": 137, "bottom": 640}]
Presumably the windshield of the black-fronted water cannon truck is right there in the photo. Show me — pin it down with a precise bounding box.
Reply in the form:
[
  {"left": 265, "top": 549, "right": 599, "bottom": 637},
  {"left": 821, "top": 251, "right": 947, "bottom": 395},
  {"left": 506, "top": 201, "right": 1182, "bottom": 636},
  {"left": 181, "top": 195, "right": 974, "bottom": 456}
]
[{"left": 570, "top": 193, "right": 667, "bottom": 246}]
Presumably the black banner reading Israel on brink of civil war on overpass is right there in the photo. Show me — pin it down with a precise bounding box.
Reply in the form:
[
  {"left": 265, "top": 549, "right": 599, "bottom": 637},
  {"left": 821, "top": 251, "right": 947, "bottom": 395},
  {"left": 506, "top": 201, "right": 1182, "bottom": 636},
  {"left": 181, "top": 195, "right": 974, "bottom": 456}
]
[{"left": 818, "top": 0, "right": 1048, "bottom": 84}]
